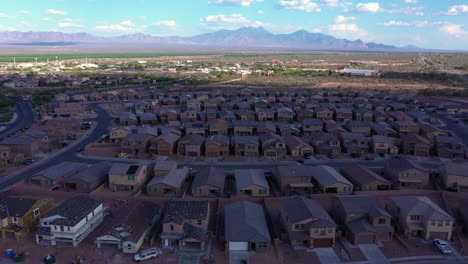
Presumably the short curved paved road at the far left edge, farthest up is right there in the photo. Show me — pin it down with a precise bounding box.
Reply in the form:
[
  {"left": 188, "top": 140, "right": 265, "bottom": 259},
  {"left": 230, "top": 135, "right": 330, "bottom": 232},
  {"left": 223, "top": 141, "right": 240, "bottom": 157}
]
[{"left": 0, "top": 96, "right": 36, "bottom": 140}]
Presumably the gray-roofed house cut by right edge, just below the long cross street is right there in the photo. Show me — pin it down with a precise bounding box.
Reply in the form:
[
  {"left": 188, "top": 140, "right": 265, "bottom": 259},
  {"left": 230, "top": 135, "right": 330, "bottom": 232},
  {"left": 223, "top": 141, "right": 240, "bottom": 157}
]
[{"left": 441, "top": 162, "right": 468, "bottom": 191}]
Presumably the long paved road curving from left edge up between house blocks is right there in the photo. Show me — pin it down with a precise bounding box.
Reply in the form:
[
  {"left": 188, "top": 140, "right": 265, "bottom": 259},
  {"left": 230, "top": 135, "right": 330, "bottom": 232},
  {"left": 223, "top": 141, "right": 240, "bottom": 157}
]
[{"left": 0, "top": 104, "right": 113, "bottom": 190}]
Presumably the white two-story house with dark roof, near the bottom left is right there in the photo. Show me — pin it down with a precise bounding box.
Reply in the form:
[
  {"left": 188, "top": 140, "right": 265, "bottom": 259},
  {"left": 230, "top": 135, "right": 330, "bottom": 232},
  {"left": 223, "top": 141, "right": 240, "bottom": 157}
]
[{"left": 36, "top": 195, "right": 104, "bottom": 247}]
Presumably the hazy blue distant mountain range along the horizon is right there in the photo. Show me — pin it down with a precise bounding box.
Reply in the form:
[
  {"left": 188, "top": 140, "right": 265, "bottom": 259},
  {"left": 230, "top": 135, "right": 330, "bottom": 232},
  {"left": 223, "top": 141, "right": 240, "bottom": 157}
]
[{"left": 0, "top": 27, "right": 408, "bottom": 51}]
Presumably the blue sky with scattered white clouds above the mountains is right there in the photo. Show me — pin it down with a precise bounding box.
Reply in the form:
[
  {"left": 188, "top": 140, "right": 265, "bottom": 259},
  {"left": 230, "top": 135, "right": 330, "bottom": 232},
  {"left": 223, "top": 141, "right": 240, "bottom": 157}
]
[{"left": 0, "top": 0, "right": 468, "bottom": 50}]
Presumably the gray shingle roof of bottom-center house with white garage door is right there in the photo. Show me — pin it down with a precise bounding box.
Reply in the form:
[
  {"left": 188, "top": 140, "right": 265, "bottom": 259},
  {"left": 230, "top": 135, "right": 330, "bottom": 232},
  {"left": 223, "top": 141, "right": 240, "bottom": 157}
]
[{"left": 224, "top": 201, "right": 271, "bottom": 242}]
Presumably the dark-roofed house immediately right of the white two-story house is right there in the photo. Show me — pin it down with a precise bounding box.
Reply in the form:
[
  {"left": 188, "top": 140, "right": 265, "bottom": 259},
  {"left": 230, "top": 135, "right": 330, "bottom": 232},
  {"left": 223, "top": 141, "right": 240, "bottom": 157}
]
[{"left": 95, "top": 201, "right": 161, "bottom": 253}]
